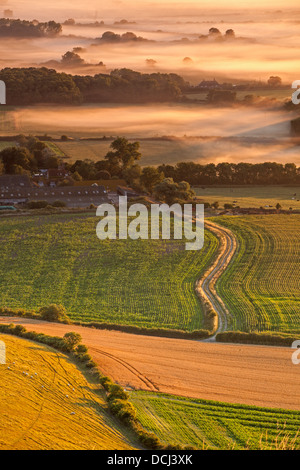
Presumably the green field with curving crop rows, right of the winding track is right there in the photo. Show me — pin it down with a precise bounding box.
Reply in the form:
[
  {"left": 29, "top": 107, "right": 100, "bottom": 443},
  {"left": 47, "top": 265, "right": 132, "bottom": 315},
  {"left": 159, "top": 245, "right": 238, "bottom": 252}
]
[{"left": 215, "top": 214, "right": 300, "bottom": 333}]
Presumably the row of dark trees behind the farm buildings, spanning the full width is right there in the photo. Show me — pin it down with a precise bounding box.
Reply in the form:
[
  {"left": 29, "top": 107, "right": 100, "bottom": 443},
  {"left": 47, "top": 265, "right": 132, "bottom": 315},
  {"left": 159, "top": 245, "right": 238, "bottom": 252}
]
[{"left": 0, "top": 135, "right": 300, "bottom": 200}]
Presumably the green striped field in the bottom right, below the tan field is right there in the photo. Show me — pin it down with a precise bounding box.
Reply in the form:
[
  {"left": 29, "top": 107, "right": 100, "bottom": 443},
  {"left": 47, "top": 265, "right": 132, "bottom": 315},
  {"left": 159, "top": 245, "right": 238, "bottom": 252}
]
[{"left": 130, "top": 391, "right": 300, "bottom": 450}]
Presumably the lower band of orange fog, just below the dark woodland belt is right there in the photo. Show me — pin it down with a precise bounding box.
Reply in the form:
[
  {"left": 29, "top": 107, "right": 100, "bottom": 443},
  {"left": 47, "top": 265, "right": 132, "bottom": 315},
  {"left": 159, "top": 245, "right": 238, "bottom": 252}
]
[{"left": 0, "top": 104, "right": 300, "bottom": 165}]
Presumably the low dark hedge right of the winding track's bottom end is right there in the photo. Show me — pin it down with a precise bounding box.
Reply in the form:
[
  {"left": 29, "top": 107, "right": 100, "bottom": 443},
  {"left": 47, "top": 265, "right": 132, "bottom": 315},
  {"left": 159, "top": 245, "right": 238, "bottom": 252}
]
[{"left": 216, "top": 331, "right": 300, "bottom": 347}]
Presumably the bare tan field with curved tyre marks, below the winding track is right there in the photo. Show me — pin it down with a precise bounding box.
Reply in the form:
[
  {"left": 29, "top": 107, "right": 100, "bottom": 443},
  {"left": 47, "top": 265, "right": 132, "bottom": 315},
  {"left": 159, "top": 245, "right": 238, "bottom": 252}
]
[{"left": 0, "top": 317, "right": 300, "bottom": 410}]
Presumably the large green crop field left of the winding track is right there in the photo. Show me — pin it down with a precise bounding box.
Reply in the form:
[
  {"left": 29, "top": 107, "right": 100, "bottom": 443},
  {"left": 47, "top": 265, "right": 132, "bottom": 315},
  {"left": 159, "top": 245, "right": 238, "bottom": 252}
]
[{"left": 0, "top": 214, "right": 219, "bottom": 331}]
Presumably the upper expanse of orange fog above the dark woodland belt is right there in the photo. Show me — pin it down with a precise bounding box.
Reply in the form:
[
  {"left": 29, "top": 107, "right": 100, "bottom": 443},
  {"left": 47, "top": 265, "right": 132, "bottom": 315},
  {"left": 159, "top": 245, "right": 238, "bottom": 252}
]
[{"left": 0, "top": 0, "right": 300, "bottom": 84}]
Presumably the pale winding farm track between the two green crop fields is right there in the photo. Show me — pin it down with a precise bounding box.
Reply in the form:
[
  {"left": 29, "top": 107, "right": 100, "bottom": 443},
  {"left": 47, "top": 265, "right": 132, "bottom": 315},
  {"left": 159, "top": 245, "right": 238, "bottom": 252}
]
[{"left": 196, "top": 221, "right": 237, "bottom": 341}]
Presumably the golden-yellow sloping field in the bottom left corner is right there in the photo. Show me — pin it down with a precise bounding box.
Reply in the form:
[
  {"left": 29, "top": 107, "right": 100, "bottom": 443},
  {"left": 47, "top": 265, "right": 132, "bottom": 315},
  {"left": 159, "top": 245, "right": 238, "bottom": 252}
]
[{"left": 0, "top": 335, "right": 135, "bottom": 450}]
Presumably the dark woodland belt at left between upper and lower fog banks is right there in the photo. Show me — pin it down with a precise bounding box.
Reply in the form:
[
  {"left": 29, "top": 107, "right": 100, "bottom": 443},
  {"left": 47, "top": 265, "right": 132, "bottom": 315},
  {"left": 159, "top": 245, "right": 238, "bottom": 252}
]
[{"left": 0, "top": 67, "right": 188, "bottom": 105}]
